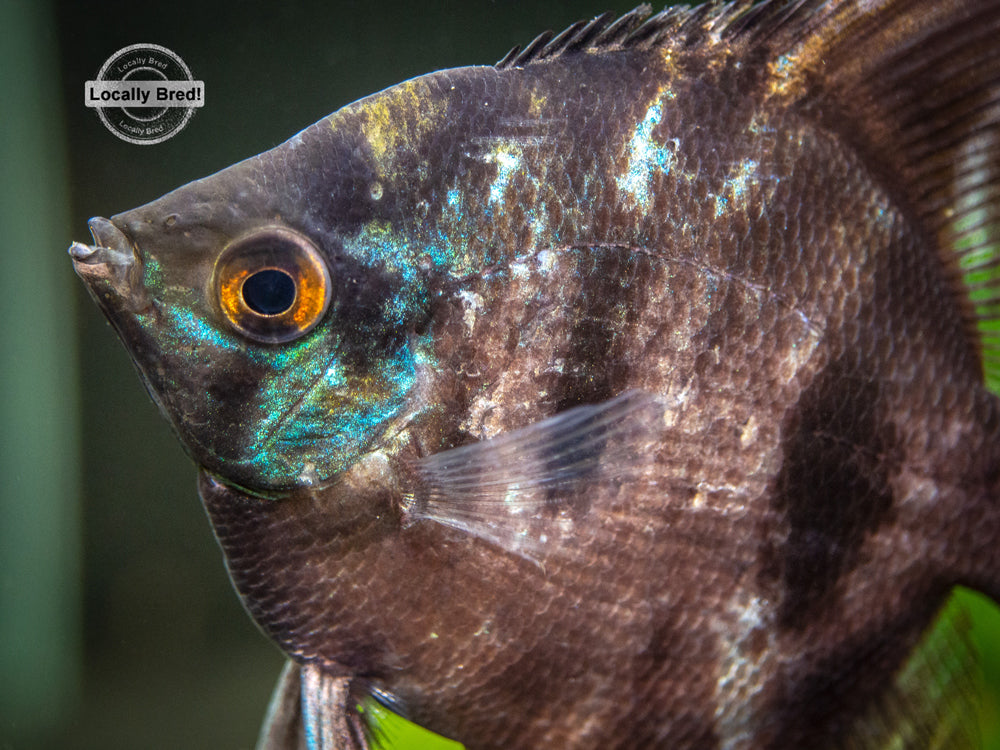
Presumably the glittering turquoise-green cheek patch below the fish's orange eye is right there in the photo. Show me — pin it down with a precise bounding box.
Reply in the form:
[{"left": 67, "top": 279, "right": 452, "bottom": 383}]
[{"left": 142, "top": 282, "right": 419, "bottom": 489}]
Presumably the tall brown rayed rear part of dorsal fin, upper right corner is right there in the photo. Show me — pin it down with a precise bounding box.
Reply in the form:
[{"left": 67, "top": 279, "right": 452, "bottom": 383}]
[{"left": 740, "top": 0, "right": 1000, "bottom": 392}]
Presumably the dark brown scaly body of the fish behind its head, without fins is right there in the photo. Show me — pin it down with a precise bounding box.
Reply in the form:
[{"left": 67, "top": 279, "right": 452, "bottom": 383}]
[{"left": 203, "top": 10, "right": 998, "bottom": 748}]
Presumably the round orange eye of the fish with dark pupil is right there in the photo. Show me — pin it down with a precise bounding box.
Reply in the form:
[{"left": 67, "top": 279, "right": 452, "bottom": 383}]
[{"left": 213, "top": 227, "right": 330, "bottom": 344}]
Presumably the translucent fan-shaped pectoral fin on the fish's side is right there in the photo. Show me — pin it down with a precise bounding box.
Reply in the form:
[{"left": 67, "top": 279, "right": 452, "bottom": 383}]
[{"left": 407, "top": 391, "right": 664, "bottom": 561}]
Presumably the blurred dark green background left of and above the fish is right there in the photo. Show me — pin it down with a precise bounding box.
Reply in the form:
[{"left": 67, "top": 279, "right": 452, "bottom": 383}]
[{"left": 0, "top": 0, "right": 1000, "bottom": 750}]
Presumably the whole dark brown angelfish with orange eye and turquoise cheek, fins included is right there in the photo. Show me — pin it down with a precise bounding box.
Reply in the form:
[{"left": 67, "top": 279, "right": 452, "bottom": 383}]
[{"left": 71, "top": 0, "right": 1000, "bottom": 749}]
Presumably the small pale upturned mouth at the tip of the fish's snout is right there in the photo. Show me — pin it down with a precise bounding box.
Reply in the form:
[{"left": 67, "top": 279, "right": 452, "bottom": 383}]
[{"left": 69, "top": 216, "right": 142, "bottom": 303}]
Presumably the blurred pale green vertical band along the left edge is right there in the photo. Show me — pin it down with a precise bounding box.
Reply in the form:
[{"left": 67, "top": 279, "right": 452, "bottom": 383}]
[{"left": 0, "top": 2, "right": 81, "bottom": 748}]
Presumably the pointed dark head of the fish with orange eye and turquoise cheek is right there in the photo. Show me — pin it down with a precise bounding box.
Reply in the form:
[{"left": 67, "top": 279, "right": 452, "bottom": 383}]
[{"left": 70, "top": 108, "right": 438, "bottom": 493}]
